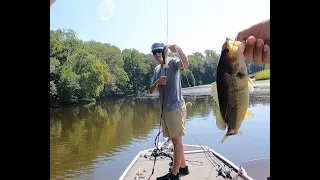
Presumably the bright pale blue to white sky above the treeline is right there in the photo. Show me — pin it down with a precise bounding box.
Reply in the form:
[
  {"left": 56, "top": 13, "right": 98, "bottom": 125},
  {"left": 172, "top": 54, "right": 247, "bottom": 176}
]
[{"left": 50, "top": 0, "right": 270, "bottom": 55}]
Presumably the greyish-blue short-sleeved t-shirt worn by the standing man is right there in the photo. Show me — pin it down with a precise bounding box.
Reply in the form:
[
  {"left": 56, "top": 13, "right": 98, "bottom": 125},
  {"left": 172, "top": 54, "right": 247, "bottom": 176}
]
[{"left": 151, "top": 58, "right": 184, "bottom": 112}]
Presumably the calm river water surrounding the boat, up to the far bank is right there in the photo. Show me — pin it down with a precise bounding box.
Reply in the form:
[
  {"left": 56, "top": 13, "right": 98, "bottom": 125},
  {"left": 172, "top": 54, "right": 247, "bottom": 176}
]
[{"left": 50, "top": 95, "right": 270, "bottom": 180}]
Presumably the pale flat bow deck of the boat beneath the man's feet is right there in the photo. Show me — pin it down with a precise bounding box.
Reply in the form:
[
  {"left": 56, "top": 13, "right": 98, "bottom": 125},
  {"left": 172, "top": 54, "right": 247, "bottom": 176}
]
[{"left": 120, "top": 145, "right": 267, "bottom": 180}]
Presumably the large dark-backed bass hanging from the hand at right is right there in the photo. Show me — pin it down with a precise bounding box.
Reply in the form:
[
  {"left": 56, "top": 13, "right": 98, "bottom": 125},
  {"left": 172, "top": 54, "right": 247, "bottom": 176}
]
[{"left": 211, "top": 38, "right": 253, "bottom": 143}]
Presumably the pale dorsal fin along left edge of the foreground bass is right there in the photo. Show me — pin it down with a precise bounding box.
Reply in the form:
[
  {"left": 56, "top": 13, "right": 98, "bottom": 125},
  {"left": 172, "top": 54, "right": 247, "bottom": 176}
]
[{"left": 211, "top": 82, "right": 227, "bottom": 130}]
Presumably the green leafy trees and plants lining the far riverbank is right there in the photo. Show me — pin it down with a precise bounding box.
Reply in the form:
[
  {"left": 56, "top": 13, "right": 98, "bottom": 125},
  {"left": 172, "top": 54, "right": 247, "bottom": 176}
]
[{"left": 50, "top": 29, "right": 270, "bottom": 108}]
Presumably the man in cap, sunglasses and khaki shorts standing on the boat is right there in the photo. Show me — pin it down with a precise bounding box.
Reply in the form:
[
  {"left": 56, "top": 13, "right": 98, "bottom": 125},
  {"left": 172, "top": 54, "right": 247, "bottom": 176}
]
[{"left": 151, "top": 43, "right": 189, "bottom": 180}]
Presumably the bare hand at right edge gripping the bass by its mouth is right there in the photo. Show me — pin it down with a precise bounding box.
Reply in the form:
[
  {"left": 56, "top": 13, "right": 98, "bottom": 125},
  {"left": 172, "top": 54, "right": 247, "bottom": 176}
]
[{"left": 237, "top": 19, "right": 270, "bottom": 64}]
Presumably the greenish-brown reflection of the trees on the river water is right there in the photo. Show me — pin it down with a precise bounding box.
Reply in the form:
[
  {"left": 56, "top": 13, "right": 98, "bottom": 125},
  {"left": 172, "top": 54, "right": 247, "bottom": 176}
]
[{"left": 50, "top": 92, "right": 269, "bottom": 179}]
